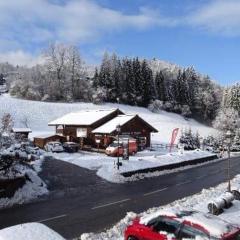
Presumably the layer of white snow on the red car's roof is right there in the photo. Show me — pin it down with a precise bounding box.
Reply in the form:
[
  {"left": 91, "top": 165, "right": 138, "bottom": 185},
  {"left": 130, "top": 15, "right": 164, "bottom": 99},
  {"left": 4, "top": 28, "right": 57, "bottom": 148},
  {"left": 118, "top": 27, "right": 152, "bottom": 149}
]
[{"left": 140, "top": 208, "right": 234, "bottom": 237}]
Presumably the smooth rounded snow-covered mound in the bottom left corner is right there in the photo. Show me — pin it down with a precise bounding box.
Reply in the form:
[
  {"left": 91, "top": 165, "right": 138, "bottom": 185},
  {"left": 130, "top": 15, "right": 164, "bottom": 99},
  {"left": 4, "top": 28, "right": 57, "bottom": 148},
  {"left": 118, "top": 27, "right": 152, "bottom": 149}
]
[{"left": 0, "top": 223, "right": 64, "bottom": 240}]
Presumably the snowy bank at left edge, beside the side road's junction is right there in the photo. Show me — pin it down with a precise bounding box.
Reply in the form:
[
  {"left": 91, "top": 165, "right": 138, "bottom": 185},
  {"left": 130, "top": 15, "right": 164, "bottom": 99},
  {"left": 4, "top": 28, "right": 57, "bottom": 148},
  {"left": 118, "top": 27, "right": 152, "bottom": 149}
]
[{"left": 0, "top": 160, "right": 48, "bottom": 208}]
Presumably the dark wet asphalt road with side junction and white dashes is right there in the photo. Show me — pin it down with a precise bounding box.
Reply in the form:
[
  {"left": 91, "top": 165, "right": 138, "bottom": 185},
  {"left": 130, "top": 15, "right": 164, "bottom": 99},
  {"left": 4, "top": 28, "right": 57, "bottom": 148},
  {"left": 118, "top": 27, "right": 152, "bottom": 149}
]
[{"left": 0, "top": 158, "right": 240, "bottom": 239}]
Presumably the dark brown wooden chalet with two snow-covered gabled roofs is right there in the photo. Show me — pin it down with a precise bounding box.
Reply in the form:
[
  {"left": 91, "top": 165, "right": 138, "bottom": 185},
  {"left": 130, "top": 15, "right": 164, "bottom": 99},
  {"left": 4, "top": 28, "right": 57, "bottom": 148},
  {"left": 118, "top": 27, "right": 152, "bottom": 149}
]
[{"left": 48, "top": 109, "right": 158, "bottom": 148}]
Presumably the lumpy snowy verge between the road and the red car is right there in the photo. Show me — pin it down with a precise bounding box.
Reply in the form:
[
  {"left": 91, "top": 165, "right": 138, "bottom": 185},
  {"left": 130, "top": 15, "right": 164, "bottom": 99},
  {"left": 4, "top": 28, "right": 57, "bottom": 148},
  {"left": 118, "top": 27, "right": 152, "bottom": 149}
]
[{"left": 79, "top": 175, "right": 240, "bottom": 240}]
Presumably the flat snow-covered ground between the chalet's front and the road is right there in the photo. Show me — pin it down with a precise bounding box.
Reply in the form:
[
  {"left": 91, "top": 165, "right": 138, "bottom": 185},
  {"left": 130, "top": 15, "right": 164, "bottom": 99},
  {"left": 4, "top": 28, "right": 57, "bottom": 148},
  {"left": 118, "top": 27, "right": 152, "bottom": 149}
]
[{"left": 51, "top": 150, "right": 217, "bottom": 182}]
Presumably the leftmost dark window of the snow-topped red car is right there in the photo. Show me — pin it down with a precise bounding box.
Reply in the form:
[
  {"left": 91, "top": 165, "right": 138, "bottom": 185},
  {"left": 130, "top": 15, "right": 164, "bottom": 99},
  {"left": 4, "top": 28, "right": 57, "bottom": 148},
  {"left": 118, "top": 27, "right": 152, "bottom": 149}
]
[{"left": 149, "top": 217, "right": 180, "bottom": 235}]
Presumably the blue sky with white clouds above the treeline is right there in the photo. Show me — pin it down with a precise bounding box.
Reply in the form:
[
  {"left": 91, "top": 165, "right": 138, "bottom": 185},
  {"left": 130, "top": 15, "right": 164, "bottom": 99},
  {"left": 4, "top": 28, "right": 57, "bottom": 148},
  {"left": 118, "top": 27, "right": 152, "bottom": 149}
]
[{"left": 0, "top": 0, "right": 240, "bottom": 85}]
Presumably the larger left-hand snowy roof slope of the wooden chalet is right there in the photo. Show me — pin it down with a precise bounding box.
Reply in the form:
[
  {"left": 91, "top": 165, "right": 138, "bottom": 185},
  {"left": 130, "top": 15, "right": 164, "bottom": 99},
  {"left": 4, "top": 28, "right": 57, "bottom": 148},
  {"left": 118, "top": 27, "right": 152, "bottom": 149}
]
[{"left": 48, "top": 109, "right": 120, "bottom": 126}]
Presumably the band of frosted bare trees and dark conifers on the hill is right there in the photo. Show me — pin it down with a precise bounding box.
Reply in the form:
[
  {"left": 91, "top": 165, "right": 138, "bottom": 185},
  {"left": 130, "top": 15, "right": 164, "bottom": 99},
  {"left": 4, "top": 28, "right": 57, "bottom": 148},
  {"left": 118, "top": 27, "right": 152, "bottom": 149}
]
[{"left": 0, "top": 44, "right": 240, "bottom": 126}]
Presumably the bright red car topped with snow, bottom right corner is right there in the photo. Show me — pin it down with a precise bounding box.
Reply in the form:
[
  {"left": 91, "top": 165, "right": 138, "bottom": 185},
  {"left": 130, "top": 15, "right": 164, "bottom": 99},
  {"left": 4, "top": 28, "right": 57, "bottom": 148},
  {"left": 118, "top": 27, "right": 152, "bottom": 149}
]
[{"left": 124, "top": 209, "right": 240, "bottom": 240}]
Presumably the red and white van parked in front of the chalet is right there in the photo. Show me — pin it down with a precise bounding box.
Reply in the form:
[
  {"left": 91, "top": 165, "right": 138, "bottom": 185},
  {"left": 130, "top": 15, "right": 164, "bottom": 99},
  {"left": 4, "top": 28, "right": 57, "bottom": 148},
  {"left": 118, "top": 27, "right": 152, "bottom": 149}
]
[{"left": 105, "top": 139, "right": 137, "bottom": 157}]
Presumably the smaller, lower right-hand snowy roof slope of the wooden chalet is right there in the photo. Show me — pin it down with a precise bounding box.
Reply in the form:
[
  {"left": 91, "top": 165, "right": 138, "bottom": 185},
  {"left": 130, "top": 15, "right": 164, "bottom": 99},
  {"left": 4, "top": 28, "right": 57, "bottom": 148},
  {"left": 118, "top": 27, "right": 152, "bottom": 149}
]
[{"left": 92, "top": 115, "right": 136, "bottom": 133}]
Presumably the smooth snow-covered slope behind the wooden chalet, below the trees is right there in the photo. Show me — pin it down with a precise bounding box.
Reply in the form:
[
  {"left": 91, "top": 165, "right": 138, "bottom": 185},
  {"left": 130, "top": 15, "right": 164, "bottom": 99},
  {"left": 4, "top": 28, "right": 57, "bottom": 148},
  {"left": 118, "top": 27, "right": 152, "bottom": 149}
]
[{"left": 0, "top": 94, "right": 216, "bottom": 143}]
